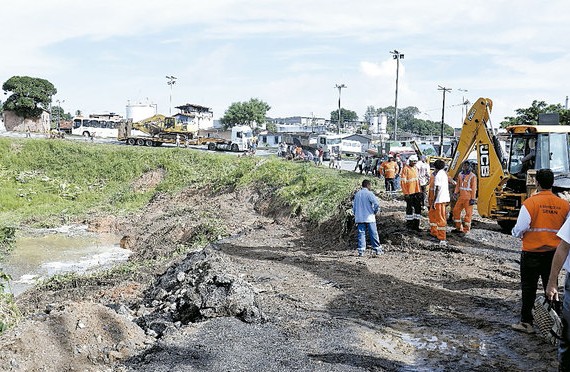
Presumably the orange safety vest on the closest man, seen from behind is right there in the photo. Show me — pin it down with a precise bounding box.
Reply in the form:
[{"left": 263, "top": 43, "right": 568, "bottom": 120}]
[{"left": 522, "top": 190, "right": 570, "bottom": 252}]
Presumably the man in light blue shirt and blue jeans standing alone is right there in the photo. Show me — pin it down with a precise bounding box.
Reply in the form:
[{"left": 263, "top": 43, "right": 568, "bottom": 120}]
[{"left": 352, "top": 180, "right": 384, "bottom": 257}]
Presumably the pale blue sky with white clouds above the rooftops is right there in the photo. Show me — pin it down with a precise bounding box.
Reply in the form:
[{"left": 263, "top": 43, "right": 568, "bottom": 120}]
[{"left": 0, "top": 0, "right": 570, "bottom": 127}]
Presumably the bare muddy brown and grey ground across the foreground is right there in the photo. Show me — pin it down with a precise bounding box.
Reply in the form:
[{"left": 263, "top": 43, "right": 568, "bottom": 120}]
[{"left": 0, "top": 186, "right": 557, "bottom": 371}]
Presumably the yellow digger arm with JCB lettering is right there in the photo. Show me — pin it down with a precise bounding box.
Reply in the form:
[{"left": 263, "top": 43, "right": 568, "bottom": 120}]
[{"left": 448, "top": 98, "right": 506, "bottom": 217}]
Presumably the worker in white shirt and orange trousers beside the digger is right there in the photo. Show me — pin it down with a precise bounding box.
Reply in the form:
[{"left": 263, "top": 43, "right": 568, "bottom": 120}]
[{"left": 430, "top": 159, "right": 450, "bottom": 247}]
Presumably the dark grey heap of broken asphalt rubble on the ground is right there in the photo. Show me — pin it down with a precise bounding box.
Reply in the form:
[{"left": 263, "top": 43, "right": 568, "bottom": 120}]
[{"left": 136, "top": 246, "right": 263, "bottom": 337}]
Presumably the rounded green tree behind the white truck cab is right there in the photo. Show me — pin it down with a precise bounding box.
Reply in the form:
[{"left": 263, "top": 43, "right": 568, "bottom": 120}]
[{"left": 220, "top": 98, "right": 271, "bottom": 129}]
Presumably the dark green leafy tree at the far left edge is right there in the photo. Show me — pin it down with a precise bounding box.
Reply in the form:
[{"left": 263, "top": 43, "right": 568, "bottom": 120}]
[{"left": 2, "top": 76, "right": 57, "bottom": 118}]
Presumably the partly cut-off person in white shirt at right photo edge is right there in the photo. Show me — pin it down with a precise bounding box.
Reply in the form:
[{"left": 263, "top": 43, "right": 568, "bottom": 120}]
[{"left": 546, "top": 219, "right": 570, "bottom": 372}]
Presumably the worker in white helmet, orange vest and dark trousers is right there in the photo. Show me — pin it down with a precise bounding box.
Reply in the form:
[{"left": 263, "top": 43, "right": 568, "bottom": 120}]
[{"left": 400, "top": 155, "right": 424, "bottom": 231}]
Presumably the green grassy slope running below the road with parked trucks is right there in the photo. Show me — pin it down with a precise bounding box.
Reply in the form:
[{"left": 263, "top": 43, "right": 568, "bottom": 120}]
[{"left": 0, "top": 138, "right": 378, "bottom": 227}]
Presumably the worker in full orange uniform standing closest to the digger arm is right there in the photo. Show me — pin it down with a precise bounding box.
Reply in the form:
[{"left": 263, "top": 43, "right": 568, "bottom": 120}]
[{"left": 453, "top": 162, "right": 477, "bottom": 234}]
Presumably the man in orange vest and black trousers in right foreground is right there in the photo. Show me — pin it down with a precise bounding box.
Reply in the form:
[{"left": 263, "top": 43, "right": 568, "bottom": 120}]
[{"left": 511, "top": 169, "right": 570, "bottom": 333}]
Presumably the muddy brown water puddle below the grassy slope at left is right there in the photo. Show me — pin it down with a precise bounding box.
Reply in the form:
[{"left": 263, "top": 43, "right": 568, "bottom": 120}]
[{"left": 0, "top": 225, "right": 132, "bottom": 296}]
